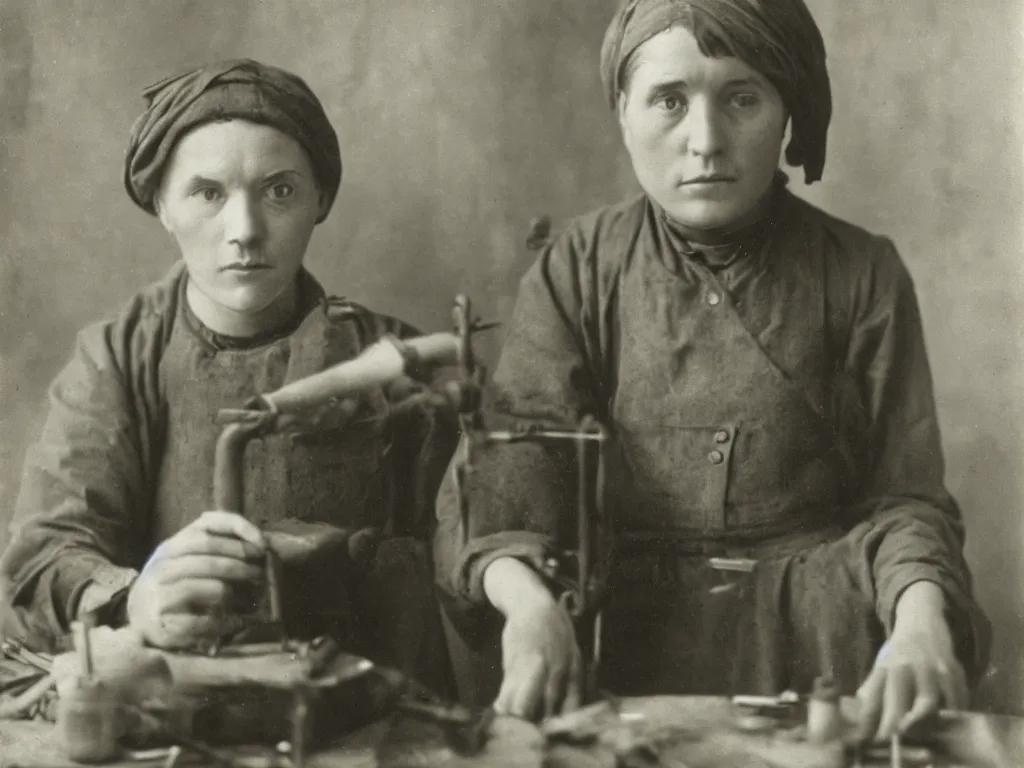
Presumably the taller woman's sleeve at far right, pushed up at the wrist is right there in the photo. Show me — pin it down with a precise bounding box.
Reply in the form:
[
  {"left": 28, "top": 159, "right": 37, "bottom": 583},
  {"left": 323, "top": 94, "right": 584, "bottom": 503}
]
[{"left": 847, "top": 241, "right": 990, "bottom": 679}]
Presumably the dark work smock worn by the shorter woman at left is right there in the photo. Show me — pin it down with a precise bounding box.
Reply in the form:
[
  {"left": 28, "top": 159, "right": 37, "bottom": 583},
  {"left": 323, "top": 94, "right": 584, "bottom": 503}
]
[{"left": 0, "top": 265, "right": 455, "bottom": 692}]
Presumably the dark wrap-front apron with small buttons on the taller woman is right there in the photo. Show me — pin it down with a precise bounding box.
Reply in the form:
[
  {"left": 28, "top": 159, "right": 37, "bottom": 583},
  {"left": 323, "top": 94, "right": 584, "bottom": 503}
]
[{"left": 600, "top": 227, "right": 882, "bottom": 695}]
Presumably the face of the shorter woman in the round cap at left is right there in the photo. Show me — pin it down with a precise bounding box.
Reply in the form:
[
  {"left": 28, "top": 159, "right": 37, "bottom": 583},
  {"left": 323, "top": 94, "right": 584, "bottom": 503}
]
[{"left": 157, "top": 120, "right": 324, "bottom": 321}]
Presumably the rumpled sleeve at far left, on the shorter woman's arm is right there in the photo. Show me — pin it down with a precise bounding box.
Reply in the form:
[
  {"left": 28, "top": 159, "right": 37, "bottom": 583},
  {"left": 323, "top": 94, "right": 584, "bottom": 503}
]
[{"left": 0, "top": 324, "right": 146, "bottom": 649}]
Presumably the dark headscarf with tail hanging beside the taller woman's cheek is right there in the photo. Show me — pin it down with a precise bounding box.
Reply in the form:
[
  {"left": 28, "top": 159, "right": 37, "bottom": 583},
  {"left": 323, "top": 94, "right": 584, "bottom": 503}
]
[{"left": 601, "top": 0, "right": 831, "bottom": 183}]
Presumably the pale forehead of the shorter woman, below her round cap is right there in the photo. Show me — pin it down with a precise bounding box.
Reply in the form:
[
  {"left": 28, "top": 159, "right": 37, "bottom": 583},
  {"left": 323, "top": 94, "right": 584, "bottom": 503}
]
[{"left": 159, "top": 120, "right": 311, "bottom": 177}]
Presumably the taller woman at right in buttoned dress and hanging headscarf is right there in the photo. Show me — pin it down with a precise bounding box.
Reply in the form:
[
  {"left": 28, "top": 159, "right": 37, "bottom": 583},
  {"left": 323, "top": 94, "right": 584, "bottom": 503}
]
[{"left": 435, "top": 0, "right": 987, "bottom": 736}]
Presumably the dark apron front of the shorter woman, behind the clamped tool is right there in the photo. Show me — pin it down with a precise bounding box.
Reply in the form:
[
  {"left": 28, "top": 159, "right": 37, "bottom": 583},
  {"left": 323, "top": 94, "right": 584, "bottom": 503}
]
[{"left": 151, "top": 281, "right": 439, "bottom": 677}]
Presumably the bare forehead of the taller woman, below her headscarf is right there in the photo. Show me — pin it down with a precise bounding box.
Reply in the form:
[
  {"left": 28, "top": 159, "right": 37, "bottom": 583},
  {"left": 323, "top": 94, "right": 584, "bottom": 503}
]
[{"left": 632, "top": 26, "right": 767, "bottom": 88}]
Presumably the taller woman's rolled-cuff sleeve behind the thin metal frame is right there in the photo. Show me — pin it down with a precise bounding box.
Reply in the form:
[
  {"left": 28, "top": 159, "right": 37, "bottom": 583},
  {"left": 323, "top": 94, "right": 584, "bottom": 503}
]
[{"left": 434, "top": 233, "right": 602, "bottom": 605}]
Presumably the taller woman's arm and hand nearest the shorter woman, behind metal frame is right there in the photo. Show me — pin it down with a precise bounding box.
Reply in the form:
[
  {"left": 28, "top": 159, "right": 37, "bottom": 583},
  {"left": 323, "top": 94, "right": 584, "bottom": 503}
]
[{"left": 434, "top": 238, "right": 601, "bottom": 718}]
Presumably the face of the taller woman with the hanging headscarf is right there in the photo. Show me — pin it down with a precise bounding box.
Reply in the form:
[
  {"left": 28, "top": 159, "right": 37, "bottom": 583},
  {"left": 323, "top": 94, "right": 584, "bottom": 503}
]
[{"left": 618, "top": 27, "right": 786, "bottom": 229}]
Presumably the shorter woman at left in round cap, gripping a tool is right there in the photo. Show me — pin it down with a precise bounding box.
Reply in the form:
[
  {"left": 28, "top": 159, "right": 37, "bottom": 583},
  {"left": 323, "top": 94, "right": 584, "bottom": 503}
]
[{"left": 0, "top": 60, "right": 454, "bottom": 692}]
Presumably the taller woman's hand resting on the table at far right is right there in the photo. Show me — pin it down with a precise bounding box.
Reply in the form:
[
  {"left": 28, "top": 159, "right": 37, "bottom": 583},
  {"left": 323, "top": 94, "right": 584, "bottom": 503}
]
[{"left": 857, "top": 582, "right": 968, "bottom": 741}]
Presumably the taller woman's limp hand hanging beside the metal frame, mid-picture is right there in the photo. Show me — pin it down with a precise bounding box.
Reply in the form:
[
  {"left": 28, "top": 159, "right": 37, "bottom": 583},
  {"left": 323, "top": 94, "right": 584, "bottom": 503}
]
[{"left": 484, "top": 558, "right": 582, "bottom": 720}]
